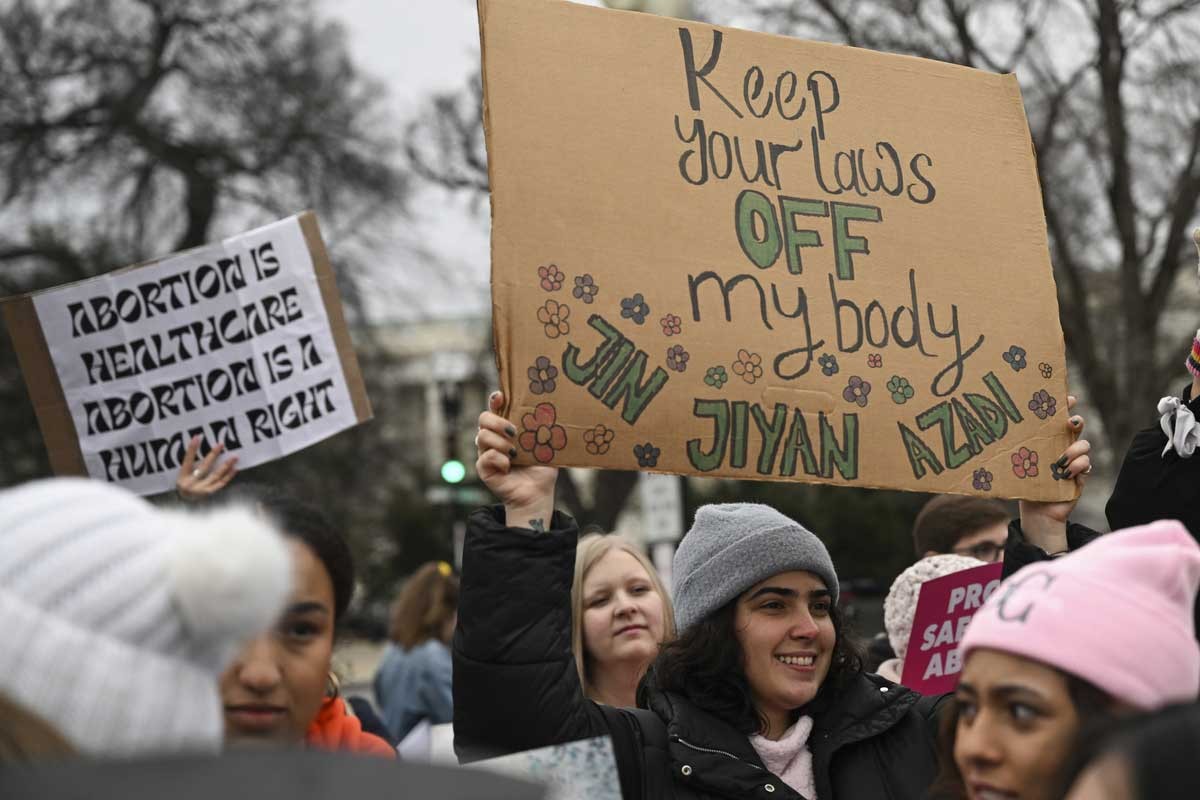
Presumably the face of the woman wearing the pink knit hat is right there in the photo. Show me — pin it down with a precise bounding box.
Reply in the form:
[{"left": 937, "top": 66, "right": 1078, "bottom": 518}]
[{"left": 954, "top": 649, "right": 1079, "bottom": 800}]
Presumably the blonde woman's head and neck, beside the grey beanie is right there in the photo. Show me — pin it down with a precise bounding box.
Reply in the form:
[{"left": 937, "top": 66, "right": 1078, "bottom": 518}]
[{"left": 571, "top": 534, "right": 674, "bottom": 708}]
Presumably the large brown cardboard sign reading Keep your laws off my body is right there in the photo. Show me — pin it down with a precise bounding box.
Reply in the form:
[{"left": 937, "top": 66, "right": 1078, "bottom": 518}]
[{"left": 479, "top": 0, "right": 1075, "bottom": 499}]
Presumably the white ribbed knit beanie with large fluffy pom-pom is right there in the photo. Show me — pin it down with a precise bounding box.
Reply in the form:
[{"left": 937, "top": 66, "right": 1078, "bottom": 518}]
[{"left": 0, "top": 479, "right": 293, "bottom": 756}]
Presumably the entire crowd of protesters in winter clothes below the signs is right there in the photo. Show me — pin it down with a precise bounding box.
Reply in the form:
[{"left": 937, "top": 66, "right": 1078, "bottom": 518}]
[{"left": 0, "top": 333, "right": 1200, "bottom": 800}]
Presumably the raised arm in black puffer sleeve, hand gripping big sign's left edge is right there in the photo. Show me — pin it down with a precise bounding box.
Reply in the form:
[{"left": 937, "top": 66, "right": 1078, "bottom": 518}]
[{"left": 454, "top": 395, "right": 610, "bottom": 762}]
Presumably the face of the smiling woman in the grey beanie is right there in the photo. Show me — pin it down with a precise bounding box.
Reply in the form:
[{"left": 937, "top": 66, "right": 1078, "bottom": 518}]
[{"left": 733, "top": 570, "right": 838, "bottom": 739}]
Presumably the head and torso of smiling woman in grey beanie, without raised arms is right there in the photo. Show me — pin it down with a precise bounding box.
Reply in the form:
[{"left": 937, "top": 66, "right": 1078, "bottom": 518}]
[{"left": 643, "top": 503, "right": 941, "bottom": 798}]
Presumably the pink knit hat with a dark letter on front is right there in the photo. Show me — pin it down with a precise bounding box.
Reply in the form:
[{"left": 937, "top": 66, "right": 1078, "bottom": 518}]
[{"left": 960, "top": 521, "right": 1200, "bottom": 710}]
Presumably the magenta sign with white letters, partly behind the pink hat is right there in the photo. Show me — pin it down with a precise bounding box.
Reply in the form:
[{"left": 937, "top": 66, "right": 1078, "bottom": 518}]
[{"left": 900, "top": 561, "right": 1004, "bottom": 694}]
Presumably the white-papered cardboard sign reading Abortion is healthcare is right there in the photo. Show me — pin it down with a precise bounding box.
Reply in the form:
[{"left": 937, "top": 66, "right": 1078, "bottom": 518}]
[{"left": 4, "top": 212, "right": 371, "bottom": 494}]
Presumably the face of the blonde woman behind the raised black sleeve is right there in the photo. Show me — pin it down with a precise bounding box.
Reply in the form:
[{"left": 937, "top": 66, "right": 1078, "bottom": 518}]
[{"left": 583, "top": 548, "right": 666, "bottom": 666}]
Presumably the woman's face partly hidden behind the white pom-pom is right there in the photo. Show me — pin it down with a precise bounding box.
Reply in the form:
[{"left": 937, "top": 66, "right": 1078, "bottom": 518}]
[{"left": 221, "top": 539, "right": 334, "bottom": 747}]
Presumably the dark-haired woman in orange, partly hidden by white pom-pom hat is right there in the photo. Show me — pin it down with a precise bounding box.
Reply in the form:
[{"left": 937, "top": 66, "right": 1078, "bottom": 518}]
[{"left": 221, "top": 487, "right": 395, "bottom": 757}]
